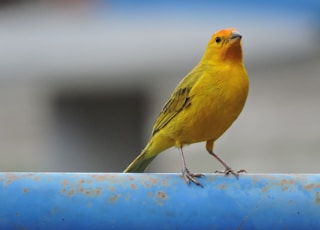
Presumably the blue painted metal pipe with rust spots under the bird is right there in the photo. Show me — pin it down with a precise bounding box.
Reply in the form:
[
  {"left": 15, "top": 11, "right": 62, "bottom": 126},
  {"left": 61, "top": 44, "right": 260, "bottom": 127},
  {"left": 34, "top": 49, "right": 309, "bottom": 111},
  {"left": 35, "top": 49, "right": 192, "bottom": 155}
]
[{"left": 0, "top": 173, "right": 320, "bottom": 229}]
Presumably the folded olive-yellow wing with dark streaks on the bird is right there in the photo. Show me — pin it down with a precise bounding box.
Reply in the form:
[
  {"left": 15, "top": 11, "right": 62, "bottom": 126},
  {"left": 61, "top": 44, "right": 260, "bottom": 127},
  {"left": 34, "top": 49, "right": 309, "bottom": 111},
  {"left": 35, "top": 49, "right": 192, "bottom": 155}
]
[{"left": 152, "top": 68, "right": 202, "bottom": 136}]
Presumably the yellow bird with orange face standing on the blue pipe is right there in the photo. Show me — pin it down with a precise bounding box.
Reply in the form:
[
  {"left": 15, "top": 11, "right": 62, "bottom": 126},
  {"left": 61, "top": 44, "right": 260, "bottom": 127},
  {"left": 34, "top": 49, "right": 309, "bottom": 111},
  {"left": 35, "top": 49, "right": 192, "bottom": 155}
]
[{"left": 124, "top": 28, "right": 249, "bottom": 185}]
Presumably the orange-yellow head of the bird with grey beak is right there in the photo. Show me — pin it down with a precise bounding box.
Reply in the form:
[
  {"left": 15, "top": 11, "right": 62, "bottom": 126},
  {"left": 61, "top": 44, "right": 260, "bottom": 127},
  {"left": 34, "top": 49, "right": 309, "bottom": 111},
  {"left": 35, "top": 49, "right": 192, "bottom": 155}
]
[{"left": 202, "top": 28, "right": 242, "bottom": 64}]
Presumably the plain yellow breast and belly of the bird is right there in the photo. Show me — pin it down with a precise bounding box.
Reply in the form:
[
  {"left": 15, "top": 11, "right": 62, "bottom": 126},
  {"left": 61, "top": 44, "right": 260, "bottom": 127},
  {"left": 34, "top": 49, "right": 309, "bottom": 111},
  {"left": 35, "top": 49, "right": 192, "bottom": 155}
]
[{"left": 163, "top": 63, "right": 248, "bottom": 146}]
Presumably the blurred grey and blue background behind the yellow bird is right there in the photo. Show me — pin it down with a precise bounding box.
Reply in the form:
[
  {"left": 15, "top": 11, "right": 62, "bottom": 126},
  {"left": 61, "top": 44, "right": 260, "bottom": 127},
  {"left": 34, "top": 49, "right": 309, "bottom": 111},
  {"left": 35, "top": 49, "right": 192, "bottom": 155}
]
[{"left": 0, "top": 0, "right": 320, "bottom": 173}]
